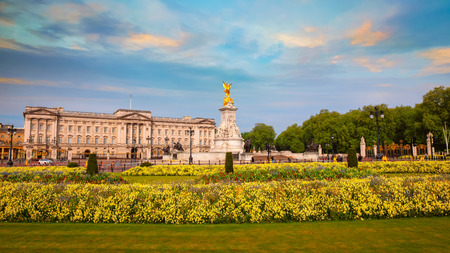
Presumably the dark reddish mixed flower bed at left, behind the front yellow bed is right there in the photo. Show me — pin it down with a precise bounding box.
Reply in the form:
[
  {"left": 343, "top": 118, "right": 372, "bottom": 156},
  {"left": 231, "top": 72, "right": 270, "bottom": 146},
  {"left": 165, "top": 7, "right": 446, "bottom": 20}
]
[{"left": 0, "top": 171, "right": 128, "bottom": 184}]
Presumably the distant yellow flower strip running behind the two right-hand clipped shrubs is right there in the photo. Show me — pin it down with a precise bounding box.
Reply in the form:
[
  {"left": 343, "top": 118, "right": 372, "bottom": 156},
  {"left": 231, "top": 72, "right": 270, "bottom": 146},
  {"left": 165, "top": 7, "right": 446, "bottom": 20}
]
[{"left": 123, "top": 161, "right": 450, "bottom": 176}]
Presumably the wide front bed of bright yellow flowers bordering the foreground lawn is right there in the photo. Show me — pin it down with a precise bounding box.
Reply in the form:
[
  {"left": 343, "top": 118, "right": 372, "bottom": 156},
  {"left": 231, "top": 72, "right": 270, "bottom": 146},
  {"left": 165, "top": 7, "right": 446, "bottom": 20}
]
[{"left": 0, "top": 175, "right": 450, "bottom": 224}]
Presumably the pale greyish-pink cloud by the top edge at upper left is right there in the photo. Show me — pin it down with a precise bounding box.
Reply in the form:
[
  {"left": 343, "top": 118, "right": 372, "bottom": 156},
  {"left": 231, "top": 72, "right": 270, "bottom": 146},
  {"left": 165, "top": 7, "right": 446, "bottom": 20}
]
[{"left": 44, "top": 3, "right": 105, "bottom": 24}]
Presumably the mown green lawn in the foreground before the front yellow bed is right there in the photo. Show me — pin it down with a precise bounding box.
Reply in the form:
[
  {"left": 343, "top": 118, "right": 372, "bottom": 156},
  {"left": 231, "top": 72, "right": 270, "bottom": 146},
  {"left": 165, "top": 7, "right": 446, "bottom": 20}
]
[{"left": 0, "top": 217, "right": 450, "bottom": 252}]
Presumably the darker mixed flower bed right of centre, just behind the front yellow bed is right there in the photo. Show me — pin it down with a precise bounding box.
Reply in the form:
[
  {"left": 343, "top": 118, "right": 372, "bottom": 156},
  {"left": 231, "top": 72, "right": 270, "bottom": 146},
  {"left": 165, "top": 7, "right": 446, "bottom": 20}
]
[{"left": 196, "top": 166, "right": 378, "bottom": 184}]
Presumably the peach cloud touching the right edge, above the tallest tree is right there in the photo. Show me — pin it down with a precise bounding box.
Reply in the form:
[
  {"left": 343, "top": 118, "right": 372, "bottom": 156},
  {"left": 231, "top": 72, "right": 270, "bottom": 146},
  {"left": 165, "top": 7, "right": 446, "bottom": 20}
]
[{"left": 419, "top": 48, "right": 450, "bottom": 75}]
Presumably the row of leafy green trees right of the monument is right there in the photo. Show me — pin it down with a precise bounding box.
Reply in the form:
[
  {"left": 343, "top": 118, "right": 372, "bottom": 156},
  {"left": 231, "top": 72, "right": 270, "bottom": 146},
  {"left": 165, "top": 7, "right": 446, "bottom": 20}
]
[{"left": 242, "top": 86, "right": 450, "bottom": 153}]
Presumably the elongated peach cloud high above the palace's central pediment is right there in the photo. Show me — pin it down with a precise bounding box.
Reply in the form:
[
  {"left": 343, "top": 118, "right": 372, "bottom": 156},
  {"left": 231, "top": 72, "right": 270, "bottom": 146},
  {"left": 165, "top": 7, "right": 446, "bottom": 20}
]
[{"left": 110, "top": 34, "right": 183, "bottom": 51}]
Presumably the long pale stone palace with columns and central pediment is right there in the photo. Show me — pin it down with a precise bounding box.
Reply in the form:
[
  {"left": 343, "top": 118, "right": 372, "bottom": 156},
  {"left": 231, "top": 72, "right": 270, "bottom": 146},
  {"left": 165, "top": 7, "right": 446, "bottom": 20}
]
[{"left": 23, "top": 106, "right": 215, "bottom": 160}]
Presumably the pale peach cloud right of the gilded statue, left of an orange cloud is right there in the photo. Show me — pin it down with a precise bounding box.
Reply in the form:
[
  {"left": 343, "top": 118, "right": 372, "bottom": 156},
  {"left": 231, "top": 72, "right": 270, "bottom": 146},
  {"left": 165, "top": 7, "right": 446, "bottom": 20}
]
[{"left": 276, "top": 27, "right": 326, "bottom": 48}]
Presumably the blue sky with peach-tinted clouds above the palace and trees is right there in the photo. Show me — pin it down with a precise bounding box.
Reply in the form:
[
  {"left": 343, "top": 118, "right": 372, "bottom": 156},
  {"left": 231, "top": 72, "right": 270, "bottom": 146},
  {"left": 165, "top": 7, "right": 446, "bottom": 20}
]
[{"left": 0, "top": 0, "right": 450, "bottom": 134}]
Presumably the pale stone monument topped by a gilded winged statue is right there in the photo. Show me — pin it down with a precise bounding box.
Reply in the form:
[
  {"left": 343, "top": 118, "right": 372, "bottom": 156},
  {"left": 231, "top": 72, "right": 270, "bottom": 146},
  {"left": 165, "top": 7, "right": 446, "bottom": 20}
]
[{"left": 211, "top": 82, "right": 244, "bottom": 154}]
